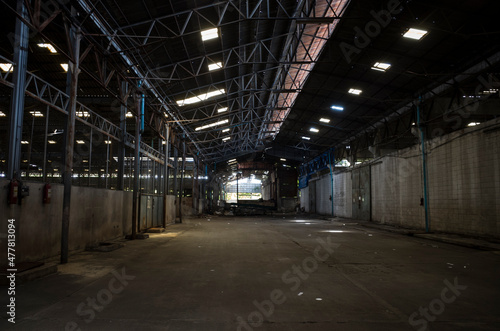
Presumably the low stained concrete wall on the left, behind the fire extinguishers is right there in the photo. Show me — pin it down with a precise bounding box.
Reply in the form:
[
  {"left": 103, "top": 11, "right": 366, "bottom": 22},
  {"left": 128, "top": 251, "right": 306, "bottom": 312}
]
[{"left": 0, "top": 180, "right": 132, "bottom": 262}]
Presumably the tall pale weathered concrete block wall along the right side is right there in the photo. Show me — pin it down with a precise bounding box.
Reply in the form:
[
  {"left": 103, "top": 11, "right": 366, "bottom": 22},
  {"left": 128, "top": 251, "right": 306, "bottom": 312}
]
[{"left": 300, "top": 119, "right": 500, "bottom": 238}]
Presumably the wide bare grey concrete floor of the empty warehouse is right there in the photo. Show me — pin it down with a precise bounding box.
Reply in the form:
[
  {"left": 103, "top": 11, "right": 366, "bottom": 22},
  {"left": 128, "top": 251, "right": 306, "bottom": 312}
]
[{"left": 0, "top": 216, "right": 500, "bottom": 331}]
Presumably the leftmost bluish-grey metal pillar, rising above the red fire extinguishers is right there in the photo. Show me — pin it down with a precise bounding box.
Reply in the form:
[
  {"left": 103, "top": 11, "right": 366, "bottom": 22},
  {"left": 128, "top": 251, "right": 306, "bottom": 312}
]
[{"left": 7, "top": 0, "right": 29, "bottom": 179}]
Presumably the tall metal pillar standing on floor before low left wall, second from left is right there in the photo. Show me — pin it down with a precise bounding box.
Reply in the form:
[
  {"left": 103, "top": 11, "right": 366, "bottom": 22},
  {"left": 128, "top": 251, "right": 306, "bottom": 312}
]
[{"left": 61, "top": 27, "right": 81, "bottom": 263}]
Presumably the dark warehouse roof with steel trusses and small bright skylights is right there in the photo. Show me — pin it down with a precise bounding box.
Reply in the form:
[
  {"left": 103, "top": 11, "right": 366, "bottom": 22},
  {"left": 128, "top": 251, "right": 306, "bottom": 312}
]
[{"left": 0, "top": 0, "right": 500, "bottom": 167}]
